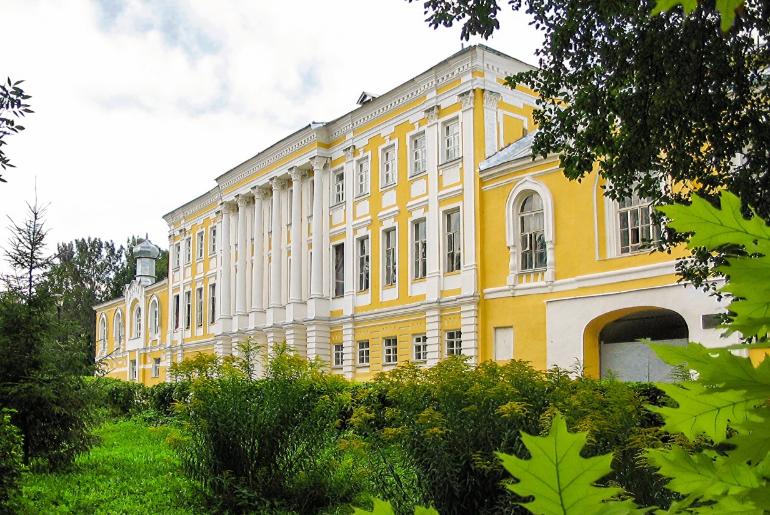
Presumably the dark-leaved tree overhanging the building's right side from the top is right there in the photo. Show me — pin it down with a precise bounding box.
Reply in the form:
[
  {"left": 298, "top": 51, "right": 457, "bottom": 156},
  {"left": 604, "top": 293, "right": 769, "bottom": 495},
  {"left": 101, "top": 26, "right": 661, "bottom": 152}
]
[{"left": 408, "top": 0, "right": 770, "bottom": 285}]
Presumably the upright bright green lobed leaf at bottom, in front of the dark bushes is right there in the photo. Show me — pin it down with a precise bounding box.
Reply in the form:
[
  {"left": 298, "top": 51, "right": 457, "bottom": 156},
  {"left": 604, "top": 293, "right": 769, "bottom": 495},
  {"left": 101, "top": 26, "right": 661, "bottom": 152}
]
[{"left": 497, "top": 414, "right": 621, "bottom": 515}]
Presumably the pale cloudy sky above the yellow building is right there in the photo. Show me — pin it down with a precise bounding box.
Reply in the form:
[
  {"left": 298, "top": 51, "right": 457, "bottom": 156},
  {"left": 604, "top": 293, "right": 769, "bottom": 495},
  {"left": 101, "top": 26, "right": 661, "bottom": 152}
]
[{"left": 0, "top": 0, "right": 542, "bottom": 271}]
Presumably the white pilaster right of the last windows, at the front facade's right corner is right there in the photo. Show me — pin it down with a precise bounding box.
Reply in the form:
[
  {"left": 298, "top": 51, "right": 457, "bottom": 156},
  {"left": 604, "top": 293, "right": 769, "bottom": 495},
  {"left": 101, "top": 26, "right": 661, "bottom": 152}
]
[{"left": 458, "top": 90, "right": 477, "bottom": 295}]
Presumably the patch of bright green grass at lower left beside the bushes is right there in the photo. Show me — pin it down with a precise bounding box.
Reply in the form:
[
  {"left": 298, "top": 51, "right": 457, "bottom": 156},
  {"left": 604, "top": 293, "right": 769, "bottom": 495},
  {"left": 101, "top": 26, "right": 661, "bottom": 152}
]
[{"left": 16, "top": 420, "right": 205, "bottom": 514}]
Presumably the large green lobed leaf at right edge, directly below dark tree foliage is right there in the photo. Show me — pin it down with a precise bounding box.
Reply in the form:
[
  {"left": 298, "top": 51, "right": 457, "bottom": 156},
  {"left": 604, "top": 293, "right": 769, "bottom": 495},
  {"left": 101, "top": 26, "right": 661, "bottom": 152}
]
[{"left": 658, "top": 191, "right": 770, "bottom": 252}]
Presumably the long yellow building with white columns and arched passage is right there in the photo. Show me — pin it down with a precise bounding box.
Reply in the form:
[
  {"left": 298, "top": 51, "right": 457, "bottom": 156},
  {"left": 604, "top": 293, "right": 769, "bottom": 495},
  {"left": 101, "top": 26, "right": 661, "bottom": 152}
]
[{"left": 96, "top": 45, "right": 724, "bottom": 383}]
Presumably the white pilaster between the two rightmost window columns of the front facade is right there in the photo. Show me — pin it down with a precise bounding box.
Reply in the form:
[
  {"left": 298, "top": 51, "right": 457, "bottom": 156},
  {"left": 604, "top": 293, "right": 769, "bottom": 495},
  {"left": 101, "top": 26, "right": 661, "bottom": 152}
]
[{"left": 425, "top": 106, "right": 441, "bottom": 302}]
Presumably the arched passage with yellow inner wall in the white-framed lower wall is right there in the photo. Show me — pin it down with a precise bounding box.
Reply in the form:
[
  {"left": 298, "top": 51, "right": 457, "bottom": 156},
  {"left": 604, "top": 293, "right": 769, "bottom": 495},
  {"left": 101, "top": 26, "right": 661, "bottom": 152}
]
[{"left": 583, "top": 306, "right": 689, "bottom": 381}]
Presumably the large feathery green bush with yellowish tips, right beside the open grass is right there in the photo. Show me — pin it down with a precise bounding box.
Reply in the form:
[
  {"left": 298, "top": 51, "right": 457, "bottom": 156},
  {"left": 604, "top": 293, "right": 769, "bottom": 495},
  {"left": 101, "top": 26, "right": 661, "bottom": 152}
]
[{"left": 182, "top": 344, "right": 360, "bottom": 513}]
